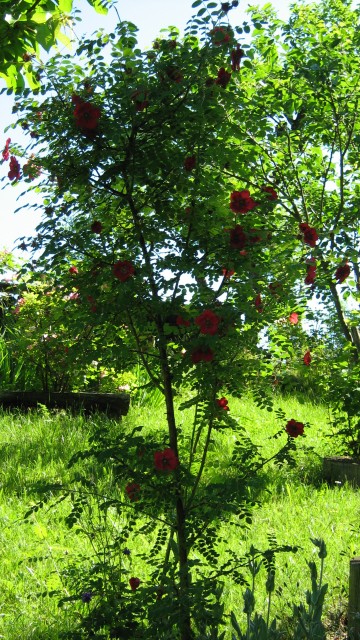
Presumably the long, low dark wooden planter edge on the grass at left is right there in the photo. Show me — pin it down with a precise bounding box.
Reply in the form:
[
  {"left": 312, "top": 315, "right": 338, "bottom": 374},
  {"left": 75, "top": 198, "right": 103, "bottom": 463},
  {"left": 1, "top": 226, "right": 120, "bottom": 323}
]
[{"left": 0, "top": 391, "right": 130, "bottom": 418}]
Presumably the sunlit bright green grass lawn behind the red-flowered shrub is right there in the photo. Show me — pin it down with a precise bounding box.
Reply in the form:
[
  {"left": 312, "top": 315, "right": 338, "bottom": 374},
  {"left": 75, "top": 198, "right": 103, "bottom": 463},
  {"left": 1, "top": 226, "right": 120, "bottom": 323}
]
[{"left": 0, "top": 398, "right": 360, "bottom": 640}]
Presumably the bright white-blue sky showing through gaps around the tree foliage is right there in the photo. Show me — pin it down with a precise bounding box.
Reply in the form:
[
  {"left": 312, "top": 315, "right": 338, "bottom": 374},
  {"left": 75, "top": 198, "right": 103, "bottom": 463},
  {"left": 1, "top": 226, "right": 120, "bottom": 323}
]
[{"left": 0, "top": 0, "right": 290, "bottom": 255}]
